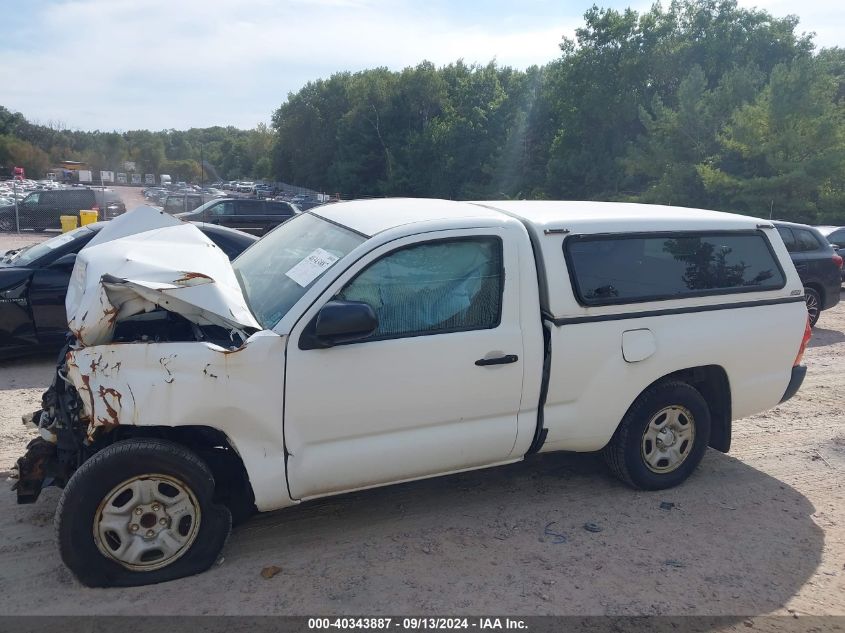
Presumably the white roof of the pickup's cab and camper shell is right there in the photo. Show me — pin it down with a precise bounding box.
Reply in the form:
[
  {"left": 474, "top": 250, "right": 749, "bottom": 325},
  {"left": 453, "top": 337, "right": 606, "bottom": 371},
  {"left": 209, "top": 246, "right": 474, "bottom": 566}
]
[{"left": 311, "top": 198, "right": 769, "bottom": 236}]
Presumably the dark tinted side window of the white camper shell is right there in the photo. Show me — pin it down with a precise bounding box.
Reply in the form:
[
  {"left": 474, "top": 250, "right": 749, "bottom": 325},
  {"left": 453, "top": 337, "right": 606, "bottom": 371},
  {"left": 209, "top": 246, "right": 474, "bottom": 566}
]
[{"left": 564, "top": 232, "right": 786, "bottom": 306}]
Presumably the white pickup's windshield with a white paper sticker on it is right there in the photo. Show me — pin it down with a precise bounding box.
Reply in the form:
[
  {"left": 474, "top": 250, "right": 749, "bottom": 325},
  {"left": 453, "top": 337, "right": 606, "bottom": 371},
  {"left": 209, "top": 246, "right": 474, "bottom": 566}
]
[{"left": 232, "top": 214, "right": 366, "bottom": 329}]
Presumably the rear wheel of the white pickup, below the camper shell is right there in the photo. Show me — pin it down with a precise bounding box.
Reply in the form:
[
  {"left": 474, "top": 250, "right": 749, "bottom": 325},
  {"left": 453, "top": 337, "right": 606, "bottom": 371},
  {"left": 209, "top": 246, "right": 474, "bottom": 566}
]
[{"left": 604, "top": 382, "right": 710, "bottom": 490}]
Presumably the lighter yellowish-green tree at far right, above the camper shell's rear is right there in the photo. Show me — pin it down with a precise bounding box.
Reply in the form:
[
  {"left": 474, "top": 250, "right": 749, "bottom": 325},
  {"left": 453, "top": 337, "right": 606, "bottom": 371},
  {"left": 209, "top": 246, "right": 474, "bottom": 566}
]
[{"left": 698, "top": 58, "right": 845, "bottom": 223}]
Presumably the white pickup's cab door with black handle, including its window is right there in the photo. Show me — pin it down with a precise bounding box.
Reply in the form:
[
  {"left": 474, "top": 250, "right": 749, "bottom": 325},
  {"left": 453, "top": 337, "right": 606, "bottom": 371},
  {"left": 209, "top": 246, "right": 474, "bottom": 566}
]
[{"left": 284, "top": 228, "right": 524, "bottom": 499}]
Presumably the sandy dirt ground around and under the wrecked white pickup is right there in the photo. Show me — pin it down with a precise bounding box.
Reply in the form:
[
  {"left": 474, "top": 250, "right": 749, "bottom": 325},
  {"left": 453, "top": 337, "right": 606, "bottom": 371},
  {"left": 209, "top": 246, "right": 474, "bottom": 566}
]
[{"left": 0, "top": 220, "right": 845, "bottom": 616}]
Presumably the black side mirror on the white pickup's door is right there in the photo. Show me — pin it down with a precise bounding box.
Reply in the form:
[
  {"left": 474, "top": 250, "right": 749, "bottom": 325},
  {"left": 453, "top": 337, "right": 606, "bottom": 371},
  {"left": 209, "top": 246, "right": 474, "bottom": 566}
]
[{"left": 299, "top": 301, "right": 378, "bottom": 349}]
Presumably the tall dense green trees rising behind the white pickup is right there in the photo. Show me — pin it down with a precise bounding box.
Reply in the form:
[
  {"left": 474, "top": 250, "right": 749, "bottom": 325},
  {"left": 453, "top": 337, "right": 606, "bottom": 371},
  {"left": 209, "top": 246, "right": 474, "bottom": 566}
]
[{"left": 273, "top": 0, "right": 845, "bottom": 223}]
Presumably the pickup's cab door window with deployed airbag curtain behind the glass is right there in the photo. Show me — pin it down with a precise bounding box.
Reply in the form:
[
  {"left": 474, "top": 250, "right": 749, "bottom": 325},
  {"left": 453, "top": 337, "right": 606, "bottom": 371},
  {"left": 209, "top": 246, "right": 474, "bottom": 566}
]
[{"left": 338, "top": 237, "right": 504, "bottom": 340}]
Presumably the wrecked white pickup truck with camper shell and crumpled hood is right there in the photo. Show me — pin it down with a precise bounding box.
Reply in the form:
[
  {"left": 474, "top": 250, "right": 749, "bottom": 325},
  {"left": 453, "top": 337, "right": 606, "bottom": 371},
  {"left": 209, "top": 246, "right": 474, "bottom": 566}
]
[{"left": 9, "top": 199, "right": 809, "bottom": 585}]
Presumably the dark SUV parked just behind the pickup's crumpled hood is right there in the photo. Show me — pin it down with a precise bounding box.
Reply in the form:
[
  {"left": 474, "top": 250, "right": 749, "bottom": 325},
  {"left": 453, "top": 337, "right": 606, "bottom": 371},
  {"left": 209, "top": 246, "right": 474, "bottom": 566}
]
[{"left": 175, "top": 198, "right": 299, "bottom": 236}]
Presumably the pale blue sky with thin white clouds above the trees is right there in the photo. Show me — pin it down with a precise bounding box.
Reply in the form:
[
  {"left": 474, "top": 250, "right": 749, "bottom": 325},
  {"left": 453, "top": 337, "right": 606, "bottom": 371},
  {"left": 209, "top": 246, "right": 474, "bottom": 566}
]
[{"left": 0, "top": 0, "right": 845, "bottom": 131}]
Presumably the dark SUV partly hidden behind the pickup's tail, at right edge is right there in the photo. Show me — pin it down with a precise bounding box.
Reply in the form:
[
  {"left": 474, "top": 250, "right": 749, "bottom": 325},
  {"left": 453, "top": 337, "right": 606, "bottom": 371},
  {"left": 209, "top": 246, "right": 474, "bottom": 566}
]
[{"left": 773, "top": 222, "right": 842, "bottom": 325}]
